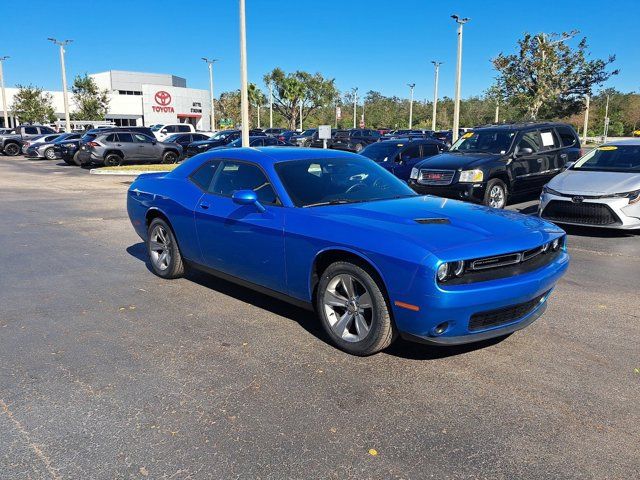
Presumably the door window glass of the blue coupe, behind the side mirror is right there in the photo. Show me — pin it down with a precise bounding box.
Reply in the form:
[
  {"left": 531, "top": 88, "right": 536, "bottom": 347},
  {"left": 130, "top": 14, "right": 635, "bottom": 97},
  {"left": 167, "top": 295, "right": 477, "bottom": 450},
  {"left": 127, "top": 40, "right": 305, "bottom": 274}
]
[{"left": 210, "top": 161, "right": 277, "bottom": 204}]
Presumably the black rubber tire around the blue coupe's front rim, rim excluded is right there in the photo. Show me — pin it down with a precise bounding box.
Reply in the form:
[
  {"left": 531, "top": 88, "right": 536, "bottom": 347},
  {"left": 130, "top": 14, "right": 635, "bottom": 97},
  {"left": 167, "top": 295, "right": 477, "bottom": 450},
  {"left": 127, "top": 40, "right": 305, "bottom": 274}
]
[{"left": 316, "top": 261, "right": 397, "bottom": 356}]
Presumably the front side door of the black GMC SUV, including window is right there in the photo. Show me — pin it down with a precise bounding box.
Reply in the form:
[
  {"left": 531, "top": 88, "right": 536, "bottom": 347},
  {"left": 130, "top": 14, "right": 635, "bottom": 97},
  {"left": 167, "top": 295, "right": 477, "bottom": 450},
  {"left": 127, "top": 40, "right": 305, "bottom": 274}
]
[{"left": 510, "top": 130, "right": 543, "bottom": 193}]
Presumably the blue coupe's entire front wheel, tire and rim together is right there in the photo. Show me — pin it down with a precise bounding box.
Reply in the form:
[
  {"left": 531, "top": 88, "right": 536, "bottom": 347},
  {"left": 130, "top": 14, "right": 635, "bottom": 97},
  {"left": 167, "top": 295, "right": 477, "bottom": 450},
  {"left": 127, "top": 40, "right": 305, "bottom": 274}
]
[{"left": 316, "top": 262, "right": 396, "bottom": 356}]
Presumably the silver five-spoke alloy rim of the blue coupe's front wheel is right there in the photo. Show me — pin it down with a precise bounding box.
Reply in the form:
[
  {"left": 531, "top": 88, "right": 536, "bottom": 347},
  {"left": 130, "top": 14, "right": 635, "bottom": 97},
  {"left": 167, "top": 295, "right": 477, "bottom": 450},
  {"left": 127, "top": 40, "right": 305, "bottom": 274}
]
[{"left": 322, "top": 273, "right": 374, "bottom": 342}]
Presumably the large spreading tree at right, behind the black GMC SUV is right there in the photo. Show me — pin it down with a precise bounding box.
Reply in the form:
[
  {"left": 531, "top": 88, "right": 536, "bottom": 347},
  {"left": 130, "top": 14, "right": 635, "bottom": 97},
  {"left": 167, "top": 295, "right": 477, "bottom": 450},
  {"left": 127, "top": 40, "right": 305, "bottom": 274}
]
[{"left": 492, "top": 31, "right": 618, "bottom": 119}]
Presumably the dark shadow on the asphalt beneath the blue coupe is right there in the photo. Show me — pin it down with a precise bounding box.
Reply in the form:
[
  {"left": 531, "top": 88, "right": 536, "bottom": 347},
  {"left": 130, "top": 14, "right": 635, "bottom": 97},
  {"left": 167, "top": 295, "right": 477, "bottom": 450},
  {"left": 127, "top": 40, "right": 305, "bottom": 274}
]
[{"left": 127, "top": 242, "right": 506, "bottom": 360}]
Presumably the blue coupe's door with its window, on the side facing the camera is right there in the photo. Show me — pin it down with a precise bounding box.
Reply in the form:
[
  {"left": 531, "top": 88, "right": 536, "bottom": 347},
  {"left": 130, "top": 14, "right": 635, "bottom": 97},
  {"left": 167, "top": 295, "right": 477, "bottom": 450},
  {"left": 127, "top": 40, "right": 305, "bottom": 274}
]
[{"left": 195, "top": 160, "right": 286, "bottom": 292}]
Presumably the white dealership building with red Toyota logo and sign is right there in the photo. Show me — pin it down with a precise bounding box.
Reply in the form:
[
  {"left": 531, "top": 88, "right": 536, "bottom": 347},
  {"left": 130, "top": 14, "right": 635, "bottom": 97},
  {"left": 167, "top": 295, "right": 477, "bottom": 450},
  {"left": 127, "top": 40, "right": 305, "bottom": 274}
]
[{"left": 0, "top": 70, "right": 211, "bottom": 131}]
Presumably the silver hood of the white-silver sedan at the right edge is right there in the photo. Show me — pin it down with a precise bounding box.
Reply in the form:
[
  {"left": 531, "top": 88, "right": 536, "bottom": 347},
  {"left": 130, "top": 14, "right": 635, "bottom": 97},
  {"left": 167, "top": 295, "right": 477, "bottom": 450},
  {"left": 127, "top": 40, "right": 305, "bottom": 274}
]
[{"left": 548, "top": 170, "right": 640, "bottom": 195}]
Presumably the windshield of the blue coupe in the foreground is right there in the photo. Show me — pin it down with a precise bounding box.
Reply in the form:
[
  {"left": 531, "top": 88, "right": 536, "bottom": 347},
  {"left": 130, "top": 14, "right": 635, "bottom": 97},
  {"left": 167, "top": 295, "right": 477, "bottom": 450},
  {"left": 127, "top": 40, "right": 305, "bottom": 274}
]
[{"left": 275, "top": 157, "right": 417, "bottom": 207}]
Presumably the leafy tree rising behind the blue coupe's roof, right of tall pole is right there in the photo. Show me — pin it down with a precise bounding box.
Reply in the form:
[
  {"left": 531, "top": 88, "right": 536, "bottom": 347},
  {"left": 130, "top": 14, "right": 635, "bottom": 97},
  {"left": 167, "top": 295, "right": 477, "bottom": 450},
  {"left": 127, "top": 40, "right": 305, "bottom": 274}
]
[{"left": 264, "top": 68, "right": 338, "bottom": 129}]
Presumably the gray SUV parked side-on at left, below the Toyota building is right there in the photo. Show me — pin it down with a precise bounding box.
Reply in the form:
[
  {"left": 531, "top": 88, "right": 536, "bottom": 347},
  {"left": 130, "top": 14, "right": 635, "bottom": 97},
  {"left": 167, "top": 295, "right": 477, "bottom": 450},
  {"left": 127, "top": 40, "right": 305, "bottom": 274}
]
[{"left": 78, "top": 131, "right": 182, "bottom": 167}]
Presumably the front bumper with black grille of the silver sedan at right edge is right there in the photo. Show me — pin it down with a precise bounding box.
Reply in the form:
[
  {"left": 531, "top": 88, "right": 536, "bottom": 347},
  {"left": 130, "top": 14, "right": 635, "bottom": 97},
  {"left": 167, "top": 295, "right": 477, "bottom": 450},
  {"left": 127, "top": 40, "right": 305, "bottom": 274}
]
[{"left": 538, "top": 192, "right": 640, "bottom": 230}]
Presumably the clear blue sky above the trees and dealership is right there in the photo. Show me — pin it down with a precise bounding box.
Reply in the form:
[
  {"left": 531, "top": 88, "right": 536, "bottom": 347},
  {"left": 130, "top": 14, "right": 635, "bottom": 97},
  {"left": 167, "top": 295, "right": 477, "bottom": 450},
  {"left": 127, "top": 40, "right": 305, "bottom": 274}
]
[{"left": 0, "top": 0, "right": 640, "bottom": 100}]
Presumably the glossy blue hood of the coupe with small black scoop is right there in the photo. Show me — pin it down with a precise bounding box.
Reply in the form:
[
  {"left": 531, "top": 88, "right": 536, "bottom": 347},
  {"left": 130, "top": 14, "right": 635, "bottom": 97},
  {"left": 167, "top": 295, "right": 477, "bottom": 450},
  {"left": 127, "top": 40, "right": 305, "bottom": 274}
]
[{"left": 309, "top": 195, "right": 563, "bottom": 261}]
